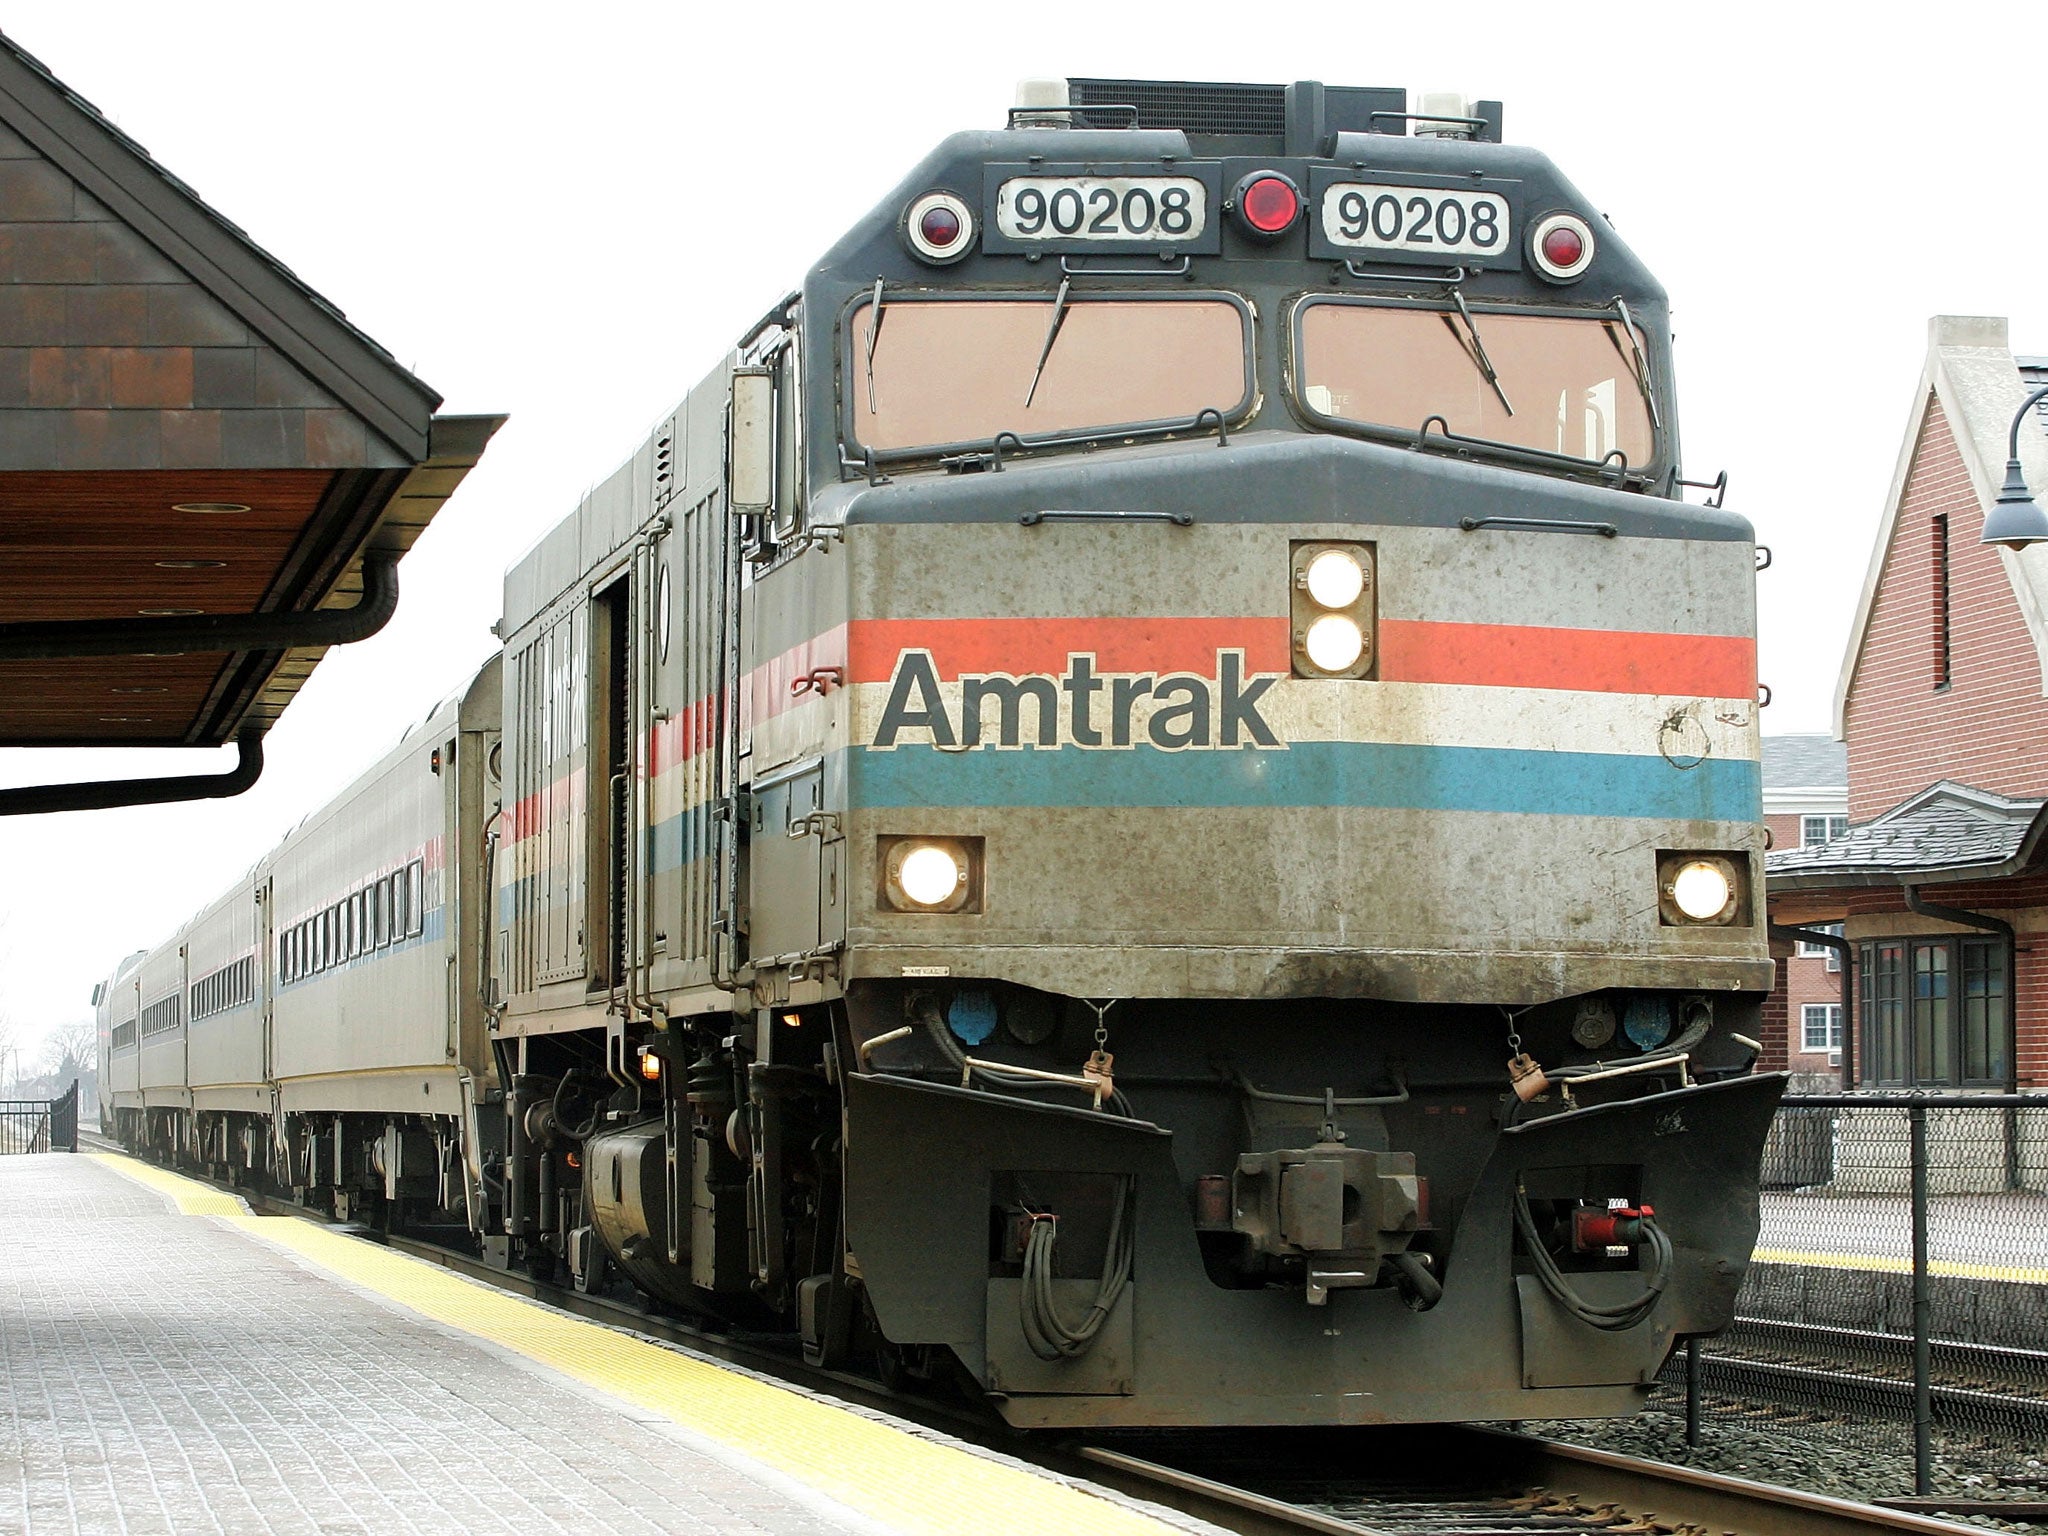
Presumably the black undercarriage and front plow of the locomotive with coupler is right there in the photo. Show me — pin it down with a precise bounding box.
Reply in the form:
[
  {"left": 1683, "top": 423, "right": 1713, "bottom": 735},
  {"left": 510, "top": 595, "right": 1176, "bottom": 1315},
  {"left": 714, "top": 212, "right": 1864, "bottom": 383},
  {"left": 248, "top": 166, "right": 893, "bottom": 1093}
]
[{"left": 456, "top": 979, "right": 1782, "bottom": 1425}]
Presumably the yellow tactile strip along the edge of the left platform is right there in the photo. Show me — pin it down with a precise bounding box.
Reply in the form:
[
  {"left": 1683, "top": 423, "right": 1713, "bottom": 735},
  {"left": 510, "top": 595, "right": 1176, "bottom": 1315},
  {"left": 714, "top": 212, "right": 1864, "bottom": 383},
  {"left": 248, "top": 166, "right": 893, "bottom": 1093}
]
[{"left": 92, "top": 1153, "right": 1182, "bottom": 1536}]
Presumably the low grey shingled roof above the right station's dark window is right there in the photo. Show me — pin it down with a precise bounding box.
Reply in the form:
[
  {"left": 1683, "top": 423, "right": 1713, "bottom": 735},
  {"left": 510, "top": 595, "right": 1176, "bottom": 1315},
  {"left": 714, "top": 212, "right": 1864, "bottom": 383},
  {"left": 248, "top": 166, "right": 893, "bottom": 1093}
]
[{"left": 1765, "top": 778, "right": 2048, "bottom": 891}]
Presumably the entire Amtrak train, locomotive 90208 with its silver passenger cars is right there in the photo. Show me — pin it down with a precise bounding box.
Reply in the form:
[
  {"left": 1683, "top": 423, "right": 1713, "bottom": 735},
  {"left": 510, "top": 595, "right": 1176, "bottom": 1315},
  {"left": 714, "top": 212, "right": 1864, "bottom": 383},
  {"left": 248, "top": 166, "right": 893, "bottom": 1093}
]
[{"left": 98, "top": 80, "right": 1782, "bottom": 1427}]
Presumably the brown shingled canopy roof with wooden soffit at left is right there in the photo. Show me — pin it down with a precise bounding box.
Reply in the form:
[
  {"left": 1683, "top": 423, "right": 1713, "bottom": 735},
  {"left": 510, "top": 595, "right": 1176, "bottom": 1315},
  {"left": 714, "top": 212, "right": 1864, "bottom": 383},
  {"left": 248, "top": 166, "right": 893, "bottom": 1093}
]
[{"left": 0, "top": 37, "right": 504, "bottom": 745}]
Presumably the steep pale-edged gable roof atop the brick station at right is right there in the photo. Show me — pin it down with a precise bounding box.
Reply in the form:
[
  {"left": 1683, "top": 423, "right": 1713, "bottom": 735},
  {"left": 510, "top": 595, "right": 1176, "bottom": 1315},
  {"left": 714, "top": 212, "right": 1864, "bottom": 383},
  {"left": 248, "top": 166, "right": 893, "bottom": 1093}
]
[{"left": 1835, "top": 315, "right": 2048, "bottom": 735}]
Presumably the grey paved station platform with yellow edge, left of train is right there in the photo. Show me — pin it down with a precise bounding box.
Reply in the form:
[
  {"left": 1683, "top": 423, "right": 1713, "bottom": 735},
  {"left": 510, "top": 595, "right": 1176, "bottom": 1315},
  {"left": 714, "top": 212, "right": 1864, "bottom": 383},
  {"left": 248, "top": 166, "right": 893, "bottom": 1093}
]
[{"left": 0, "top": 1155, "right": 1214, "bottom": 1536}]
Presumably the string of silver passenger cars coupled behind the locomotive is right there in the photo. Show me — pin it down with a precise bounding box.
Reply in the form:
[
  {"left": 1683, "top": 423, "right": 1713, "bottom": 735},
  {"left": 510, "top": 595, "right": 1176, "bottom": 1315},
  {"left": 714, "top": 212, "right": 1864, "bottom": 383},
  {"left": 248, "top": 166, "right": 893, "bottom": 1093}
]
[{"left": 94, "top": 662, "right": 502, "bottom": 1225}]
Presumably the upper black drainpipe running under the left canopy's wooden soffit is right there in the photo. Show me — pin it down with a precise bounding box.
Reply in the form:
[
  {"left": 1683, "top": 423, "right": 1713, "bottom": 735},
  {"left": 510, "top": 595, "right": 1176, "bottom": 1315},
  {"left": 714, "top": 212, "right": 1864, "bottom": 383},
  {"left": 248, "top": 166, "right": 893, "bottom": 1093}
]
[{"left": 0, "top": 549, "right": 397, "bottom": 662}]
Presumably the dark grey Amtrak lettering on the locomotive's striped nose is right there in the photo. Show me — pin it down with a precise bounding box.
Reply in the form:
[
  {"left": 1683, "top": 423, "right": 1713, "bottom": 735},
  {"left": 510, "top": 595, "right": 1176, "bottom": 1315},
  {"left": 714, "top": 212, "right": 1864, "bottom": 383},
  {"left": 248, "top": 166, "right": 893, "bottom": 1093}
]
[{"left": 872, "top": 651, "right": 1286, "bottom": 752}]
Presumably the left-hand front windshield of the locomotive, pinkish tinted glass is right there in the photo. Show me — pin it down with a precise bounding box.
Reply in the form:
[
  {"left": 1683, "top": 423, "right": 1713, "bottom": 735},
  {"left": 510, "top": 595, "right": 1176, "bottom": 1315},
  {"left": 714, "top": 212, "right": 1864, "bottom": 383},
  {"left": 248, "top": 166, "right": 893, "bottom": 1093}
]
[{"left": 848, "top": 291, "right": 1251, "bottom": 451}]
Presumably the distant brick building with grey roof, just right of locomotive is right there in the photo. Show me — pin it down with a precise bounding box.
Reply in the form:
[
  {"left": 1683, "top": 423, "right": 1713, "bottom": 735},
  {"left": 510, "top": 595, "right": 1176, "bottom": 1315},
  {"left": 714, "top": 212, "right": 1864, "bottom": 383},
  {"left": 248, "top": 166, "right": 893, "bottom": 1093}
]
[{"left": 1763, "top": 731, "right": 1849, "bottom": 1090}]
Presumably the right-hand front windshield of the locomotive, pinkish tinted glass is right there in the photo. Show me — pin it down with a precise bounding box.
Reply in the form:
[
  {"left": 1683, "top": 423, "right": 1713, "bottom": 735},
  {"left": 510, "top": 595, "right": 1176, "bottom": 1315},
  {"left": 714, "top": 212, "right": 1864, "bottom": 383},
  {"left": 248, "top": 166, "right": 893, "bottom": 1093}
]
[{"left": 1296, "top": 299, "right": 1657, "bottom": 465}]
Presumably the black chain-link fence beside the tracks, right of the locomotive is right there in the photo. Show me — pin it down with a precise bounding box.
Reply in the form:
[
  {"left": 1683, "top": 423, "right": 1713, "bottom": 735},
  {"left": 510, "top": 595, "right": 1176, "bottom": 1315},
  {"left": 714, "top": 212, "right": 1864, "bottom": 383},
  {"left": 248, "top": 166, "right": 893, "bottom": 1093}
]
[{"left": 1659, "top": 1094, "right": 2048, "bottom": 1495}]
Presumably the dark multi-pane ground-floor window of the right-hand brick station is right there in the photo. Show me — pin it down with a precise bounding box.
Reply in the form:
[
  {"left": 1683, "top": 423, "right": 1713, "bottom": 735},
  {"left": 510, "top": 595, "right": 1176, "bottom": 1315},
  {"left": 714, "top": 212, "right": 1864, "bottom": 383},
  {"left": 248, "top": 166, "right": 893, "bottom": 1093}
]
[{"left": 1864, "top": 936, "right": 2013, "bottom": 1087}]
